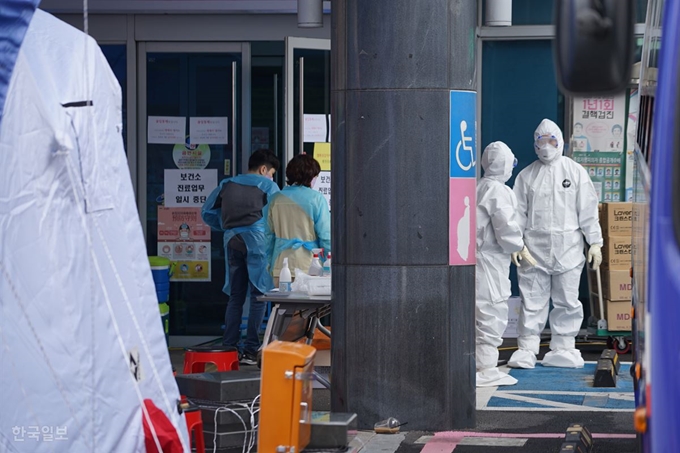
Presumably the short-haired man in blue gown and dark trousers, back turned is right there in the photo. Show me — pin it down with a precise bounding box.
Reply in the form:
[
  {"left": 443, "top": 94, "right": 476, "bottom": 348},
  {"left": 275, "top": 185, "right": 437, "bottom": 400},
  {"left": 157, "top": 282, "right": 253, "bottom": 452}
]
[{"left": 202, "top": 149, "right": 281, "bottom": 365}]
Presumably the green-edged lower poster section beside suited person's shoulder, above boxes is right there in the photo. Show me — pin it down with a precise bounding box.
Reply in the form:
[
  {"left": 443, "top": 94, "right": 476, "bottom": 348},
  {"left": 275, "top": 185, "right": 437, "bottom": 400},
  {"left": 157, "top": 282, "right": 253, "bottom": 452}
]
[{"left": 572, "top": 151, "right": 626, "bottom": 203}]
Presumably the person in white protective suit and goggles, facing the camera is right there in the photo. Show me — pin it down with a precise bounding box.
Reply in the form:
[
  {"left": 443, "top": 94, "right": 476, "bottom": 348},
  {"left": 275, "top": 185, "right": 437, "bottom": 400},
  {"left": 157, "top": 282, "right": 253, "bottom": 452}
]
[{"left": 508, "top": 119, "right": 603, "bottom": 368}]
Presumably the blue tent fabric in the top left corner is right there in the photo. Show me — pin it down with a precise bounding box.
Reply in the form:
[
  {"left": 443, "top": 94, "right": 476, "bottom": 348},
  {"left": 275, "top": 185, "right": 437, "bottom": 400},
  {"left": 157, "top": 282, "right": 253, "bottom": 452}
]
[{"left": 0, "top": 0, "right": 40, "bottom": 124}]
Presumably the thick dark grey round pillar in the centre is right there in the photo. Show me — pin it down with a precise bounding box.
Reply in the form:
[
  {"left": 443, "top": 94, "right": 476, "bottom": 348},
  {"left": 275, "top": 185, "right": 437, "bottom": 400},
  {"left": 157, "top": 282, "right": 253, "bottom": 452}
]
[{"left": 331, "top": 0, "right": 477, "bottom": 430}]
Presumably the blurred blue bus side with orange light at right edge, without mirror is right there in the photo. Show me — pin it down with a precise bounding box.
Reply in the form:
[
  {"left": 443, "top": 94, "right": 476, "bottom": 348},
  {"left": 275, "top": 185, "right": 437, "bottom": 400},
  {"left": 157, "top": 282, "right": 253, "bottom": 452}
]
[{"left": 633, "top": 0, "right": 680, "bottom": 446}]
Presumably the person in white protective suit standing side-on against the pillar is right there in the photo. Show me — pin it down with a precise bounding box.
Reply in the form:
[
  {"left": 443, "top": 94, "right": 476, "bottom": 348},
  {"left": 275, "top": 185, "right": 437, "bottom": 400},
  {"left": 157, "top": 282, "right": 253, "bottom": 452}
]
[{"left": 475, "top": 142, "right": 533, "bottom": 387}]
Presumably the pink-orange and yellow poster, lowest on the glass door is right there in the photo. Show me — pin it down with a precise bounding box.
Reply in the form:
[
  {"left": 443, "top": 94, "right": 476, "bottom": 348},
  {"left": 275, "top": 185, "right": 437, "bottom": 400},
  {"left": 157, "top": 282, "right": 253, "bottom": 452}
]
[{"left": 158, "top": 206, "right": 211, "bottom": 282}]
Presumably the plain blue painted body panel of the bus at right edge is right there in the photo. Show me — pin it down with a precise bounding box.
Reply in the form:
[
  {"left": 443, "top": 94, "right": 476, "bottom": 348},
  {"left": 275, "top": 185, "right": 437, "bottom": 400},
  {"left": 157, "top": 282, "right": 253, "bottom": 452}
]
[{"left": 647, "top": 1, "right": 680, "bottom": 452}]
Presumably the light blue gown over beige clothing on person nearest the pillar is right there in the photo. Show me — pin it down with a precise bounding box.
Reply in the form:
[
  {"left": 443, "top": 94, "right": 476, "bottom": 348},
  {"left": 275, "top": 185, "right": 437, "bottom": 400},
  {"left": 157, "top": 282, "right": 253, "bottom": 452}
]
[{"left": 265, "top": 185, "right": 331, "bottom": 277}]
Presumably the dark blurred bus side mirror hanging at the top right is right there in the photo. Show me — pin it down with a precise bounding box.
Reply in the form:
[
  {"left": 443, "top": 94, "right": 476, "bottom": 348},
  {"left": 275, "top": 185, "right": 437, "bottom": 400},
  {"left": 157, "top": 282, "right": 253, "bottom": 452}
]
[{"left": 553, "top": 0, "right": 635, "bottom": 96}]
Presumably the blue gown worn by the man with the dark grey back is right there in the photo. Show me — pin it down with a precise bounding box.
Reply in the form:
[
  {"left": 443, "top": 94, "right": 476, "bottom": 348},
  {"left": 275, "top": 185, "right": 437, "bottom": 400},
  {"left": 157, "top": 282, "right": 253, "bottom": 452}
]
[{"left": 201, "top": 173, "right": 279, "bottom": 295}]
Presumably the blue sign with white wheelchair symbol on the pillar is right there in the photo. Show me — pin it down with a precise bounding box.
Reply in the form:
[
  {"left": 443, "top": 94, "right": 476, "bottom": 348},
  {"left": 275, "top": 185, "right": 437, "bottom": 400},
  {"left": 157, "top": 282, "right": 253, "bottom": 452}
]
[{"left": 449, "top": 91, "right": 477, "bottom": 178}]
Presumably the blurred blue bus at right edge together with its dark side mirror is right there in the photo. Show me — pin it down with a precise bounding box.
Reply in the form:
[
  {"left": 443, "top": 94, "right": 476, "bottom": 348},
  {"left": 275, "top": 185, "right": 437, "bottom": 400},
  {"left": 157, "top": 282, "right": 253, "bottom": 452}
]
[{"left": 555, "top": 0, "right": 680, "bottom": 453}]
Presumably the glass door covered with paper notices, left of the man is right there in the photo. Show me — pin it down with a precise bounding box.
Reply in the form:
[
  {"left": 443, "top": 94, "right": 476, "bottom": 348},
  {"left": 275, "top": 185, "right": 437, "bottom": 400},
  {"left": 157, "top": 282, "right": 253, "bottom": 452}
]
[{"left": 138, "top": 43, "right": 250, "bottom": 337}]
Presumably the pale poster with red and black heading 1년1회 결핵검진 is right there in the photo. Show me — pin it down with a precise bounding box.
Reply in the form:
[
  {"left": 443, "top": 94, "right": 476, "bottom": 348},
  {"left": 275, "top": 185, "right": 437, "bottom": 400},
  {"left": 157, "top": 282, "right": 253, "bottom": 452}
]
[{"left": 571, "top": 94, "right": 626, "bottom": 152}]
